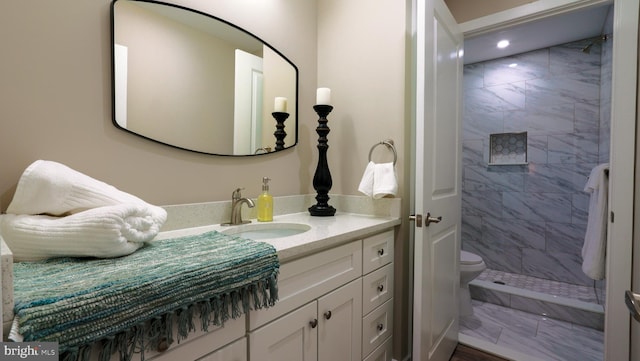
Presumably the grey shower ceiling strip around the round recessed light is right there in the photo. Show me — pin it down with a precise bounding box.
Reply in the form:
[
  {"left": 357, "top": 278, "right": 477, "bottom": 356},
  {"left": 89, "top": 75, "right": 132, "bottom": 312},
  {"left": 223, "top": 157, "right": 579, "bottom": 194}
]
[{"left": 464, "top": 4, "right": 613, "bottom": 64}]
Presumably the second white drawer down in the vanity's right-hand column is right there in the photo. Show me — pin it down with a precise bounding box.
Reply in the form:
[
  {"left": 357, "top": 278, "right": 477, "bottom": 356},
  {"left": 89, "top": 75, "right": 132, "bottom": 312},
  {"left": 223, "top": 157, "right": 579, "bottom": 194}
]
[{"left": 362, "top": 263, "right": 393, "bottom": 316}]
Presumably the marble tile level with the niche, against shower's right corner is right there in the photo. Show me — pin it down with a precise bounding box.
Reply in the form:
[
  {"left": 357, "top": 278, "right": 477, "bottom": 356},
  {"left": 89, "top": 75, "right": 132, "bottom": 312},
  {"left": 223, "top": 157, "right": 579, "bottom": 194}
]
[{"left": 548, "top": 132, "right": 598, "bottom": 163}]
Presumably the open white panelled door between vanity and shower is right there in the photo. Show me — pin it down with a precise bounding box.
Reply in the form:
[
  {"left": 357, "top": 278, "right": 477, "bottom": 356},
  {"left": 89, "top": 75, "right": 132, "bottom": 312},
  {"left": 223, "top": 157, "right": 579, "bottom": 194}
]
[{"left": 412, "top": 0, "right": 463, "bottom": 361}]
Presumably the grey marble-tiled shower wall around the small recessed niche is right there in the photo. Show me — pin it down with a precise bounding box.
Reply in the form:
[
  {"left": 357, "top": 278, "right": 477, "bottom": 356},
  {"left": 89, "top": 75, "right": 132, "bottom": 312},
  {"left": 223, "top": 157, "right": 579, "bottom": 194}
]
[{"left": 462, "top": 35, "right": 612, "bottom": 285}]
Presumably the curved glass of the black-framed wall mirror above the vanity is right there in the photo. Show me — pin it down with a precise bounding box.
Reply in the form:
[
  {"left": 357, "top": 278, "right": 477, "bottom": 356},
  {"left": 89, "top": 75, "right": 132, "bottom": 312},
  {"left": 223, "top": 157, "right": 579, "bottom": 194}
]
[{"left": 112, "top": 0, "right": 298, "bottom": 155}]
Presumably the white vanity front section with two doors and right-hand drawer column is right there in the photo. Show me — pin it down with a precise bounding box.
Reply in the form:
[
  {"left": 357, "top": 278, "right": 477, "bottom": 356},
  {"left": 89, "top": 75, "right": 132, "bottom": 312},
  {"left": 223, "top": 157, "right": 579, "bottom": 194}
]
[{"left": 248, "top": 230, "right": 394, "bottom": 361}]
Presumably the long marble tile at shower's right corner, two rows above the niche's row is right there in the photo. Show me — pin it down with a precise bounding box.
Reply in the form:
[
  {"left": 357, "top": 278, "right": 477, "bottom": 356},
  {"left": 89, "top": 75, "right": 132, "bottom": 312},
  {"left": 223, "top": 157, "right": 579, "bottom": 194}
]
[{"left": 526, "top": 69, "right": 600, "bottom": 106}]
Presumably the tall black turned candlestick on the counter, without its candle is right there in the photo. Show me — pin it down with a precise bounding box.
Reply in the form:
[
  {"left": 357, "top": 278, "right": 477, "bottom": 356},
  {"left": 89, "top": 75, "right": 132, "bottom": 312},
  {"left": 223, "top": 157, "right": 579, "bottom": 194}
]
[{"left": 309, "top": 105, "right": 336, "bottom": 217}]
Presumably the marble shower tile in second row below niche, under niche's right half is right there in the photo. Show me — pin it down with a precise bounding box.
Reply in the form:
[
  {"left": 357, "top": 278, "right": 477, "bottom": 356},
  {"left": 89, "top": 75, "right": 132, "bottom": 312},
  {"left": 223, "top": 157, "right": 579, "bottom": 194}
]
[{"left": 502, "top": 192, "right": 571, "bottom": 223}]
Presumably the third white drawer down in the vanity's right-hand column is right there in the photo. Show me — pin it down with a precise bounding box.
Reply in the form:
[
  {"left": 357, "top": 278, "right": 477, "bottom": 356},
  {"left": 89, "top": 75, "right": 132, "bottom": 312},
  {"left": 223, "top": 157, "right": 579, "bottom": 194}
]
[{"left": 362, "top": 298, "right": 393, "bottom": 355}]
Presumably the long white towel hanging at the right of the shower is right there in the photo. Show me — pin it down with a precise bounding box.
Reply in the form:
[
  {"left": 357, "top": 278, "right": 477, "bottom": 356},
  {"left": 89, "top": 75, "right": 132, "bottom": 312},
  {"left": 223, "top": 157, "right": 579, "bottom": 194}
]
[{"left": 582, "top": 163, "right": 609, "bottom": 280}]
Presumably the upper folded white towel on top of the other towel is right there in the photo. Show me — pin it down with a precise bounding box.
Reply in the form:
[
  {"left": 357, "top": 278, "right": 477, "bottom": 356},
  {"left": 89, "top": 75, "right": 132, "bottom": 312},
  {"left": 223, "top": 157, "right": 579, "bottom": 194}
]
[{"left": 7, "top": 160, "right": 167, "bottom": 223}]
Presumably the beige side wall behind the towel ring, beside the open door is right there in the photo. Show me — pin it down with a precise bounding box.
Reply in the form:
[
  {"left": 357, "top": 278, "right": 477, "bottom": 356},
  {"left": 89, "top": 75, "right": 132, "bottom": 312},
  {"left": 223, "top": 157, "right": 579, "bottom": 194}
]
[{"left": 318, "top": 0, "right": 411, "bottom": 360}]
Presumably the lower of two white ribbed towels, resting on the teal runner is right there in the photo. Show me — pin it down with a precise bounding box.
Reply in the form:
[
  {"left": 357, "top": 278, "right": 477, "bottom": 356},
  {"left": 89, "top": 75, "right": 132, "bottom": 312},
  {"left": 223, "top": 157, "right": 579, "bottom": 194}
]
[{"left": 0, "top": 204, "right": 162, "bottom": 261}]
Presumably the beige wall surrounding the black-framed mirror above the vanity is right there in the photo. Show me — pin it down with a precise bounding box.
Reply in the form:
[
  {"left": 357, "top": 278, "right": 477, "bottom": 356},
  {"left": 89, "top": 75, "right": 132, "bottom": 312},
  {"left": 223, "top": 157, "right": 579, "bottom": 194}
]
[{"left": 0, "top": 0, "right": 318, "bottom": 210}]
